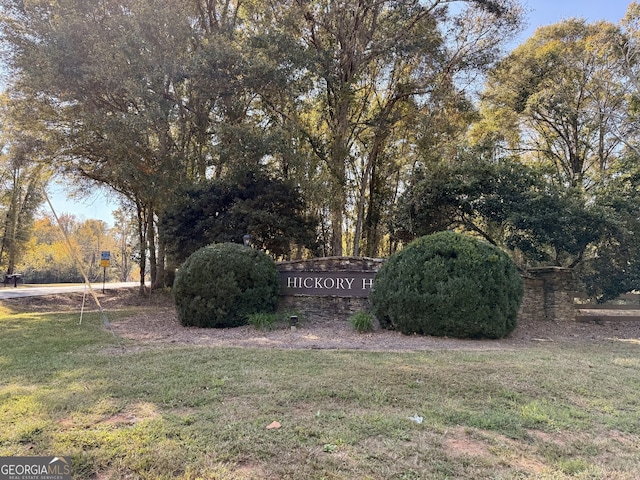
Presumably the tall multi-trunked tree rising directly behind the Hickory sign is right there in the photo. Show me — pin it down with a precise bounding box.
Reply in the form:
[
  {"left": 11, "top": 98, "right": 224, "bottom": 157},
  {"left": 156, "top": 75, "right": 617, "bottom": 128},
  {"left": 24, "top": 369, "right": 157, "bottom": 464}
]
[{"left": 262, "top": 0, "right": 521, "bottom": 255}]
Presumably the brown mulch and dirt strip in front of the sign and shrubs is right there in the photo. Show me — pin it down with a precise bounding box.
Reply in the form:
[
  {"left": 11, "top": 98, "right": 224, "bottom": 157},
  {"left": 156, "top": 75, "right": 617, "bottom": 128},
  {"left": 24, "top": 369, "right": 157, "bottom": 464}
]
[{"left": 3, "top": 289, "right": 640, "bottom": 351}]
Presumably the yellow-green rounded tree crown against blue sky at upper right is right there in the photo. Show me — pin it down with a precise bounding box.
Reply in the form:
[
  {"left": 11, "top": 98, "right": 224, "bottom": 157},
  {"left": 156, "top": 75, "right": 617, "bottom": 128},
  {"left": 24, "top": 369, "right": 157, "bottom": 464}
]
[{"left": 478, "top": 19, "right": 629, "bottom": 189}]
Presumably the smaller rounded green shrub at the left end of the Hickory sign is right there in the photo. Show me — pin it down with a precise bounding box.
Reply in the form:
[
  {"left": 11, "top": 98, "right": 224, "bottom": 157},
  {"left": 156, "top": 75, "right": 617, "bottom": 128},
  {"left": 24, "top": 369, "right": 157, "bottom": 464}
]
[{"left": 173, "top": 243, "right": 279, "bottom": 328}]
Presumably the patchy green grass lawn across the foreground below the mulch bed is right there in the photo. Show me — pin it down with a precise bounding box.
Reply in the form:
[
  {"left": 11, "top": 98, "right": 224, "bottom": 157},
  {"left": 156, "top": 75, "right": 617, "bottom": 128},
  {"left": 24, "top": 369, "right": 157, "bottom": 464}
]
[{"left": 0, "top": 298, "right": 640, "bottom": 480}]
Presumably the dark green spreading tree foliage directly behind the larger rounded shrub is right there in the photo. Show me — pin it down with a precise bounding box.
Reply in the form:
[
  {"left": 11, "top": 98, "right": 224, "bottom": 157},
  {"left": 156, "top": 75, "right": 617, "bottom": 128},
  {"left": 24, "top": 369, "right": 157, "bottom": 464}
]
[{"left": 393, "top": 158, "right": 610, "bottom": 267}]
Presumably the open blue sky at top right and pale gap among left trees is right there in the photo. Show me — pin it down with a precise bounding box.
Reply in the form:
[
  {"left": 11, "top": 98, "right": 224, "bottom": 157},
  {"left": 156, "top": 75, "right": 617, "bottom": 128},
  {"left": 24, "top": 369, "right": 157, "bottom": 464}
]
[{"left": 45, "top": 0, "right": 631, "bottom": 225}]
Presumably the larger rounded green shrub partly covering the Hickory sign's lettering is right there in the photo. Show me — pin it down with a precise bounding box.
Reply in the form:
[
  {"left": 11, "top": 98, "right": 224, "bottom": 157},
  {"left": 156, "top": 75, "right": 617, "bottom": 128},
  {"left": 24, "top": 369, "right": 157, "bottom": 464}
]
[{"left": 370, "top": 232, "right": 523, "bottom": 338}]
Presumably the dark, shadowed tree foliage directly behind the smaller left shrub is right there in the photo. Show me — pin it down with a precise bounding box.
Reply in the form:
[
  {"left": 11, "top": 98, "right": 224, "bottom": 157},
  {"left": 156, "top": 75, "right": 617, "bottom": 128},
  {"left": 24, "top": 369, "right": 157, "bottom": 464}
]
[{"left": 160, "top": 171, "right": 317, "bottom": 263}]
